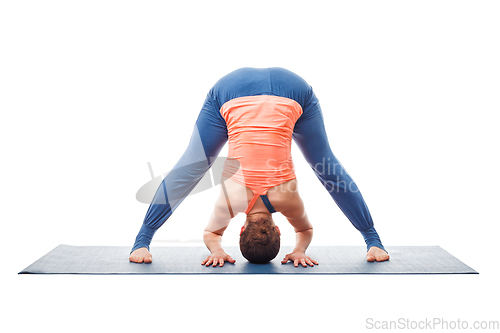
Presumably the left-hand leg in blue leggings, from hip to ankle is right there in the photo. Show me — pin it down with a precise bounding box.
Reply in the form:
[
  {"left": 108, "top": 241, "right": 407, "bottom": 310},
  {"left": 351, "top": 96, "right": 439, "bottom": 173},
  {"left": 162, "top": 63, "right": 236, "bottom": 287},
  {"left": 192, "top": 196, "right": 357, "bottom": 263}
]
[{"left": 131, "top": 91, "right": 228, "bottom": 252}]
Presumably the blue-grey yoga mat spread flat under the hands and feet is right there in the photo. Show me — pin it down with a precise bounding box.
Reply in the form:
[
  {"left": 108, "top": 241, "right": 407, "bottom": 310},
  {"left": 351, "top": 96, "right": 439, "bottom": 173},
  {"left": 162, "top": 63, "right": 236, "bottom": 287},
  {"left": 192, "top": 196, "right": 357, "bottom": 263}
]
[{"left": 19, "top": 245, "right": 478, "bottom": 274}]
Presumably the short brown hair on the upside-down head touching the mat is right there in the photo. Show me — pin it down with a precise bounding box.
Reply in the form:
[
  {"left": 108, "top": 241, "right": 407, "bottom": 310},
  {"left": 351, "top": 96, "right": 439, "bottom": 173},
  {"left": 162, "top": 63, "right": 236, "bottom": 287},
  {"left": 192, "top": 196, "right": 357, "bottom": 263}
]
[{"left": 240, "top": 218, "right": 280, "bottom": 264}]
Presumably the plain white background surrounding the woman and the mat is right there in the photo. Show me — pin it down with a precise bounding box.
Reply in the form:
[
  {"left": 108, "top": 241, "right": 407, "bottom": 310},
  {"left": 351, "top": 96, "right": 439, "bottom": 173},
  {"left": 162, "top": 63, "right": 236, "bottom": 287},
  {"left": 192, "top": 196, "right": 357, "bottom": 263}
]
[{"left": 0, "top": 0, "right": 500, "bottom": 332}]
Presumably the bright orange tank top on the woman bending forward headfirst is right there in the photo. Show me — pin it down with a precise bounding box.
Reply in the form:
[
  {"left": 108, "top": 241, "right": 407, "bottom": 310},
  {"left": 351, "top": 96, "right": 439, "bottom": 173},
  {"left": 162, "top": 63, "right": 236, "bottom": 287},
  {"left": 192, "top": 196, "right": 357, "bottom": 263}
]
[{"left": 220, "top": 95, "right": 302, "bottom": 214}]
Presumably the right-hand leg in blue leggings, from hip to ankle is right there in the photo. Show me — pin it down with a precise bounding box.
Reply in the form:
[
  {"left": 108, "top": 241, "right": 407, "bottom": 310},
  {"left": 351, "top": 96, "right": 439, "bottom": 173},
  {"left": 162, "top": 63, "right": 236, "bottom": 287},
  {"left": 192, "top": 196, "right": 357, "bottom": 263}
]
[{"left": 293, "top": 92, "right": 387, "bottom": 252}]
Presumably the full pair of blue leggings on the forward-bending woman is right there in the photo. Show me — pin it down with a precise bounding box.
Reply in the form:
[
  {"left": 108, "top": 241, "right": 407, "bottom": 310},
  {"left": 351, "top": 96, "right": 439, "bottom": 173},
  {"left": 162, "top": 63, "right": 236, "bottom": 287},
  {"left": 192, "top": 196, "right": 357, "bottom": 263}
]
[{"left": 132, "top": 67, "right": 385, "bottom": 251}]
